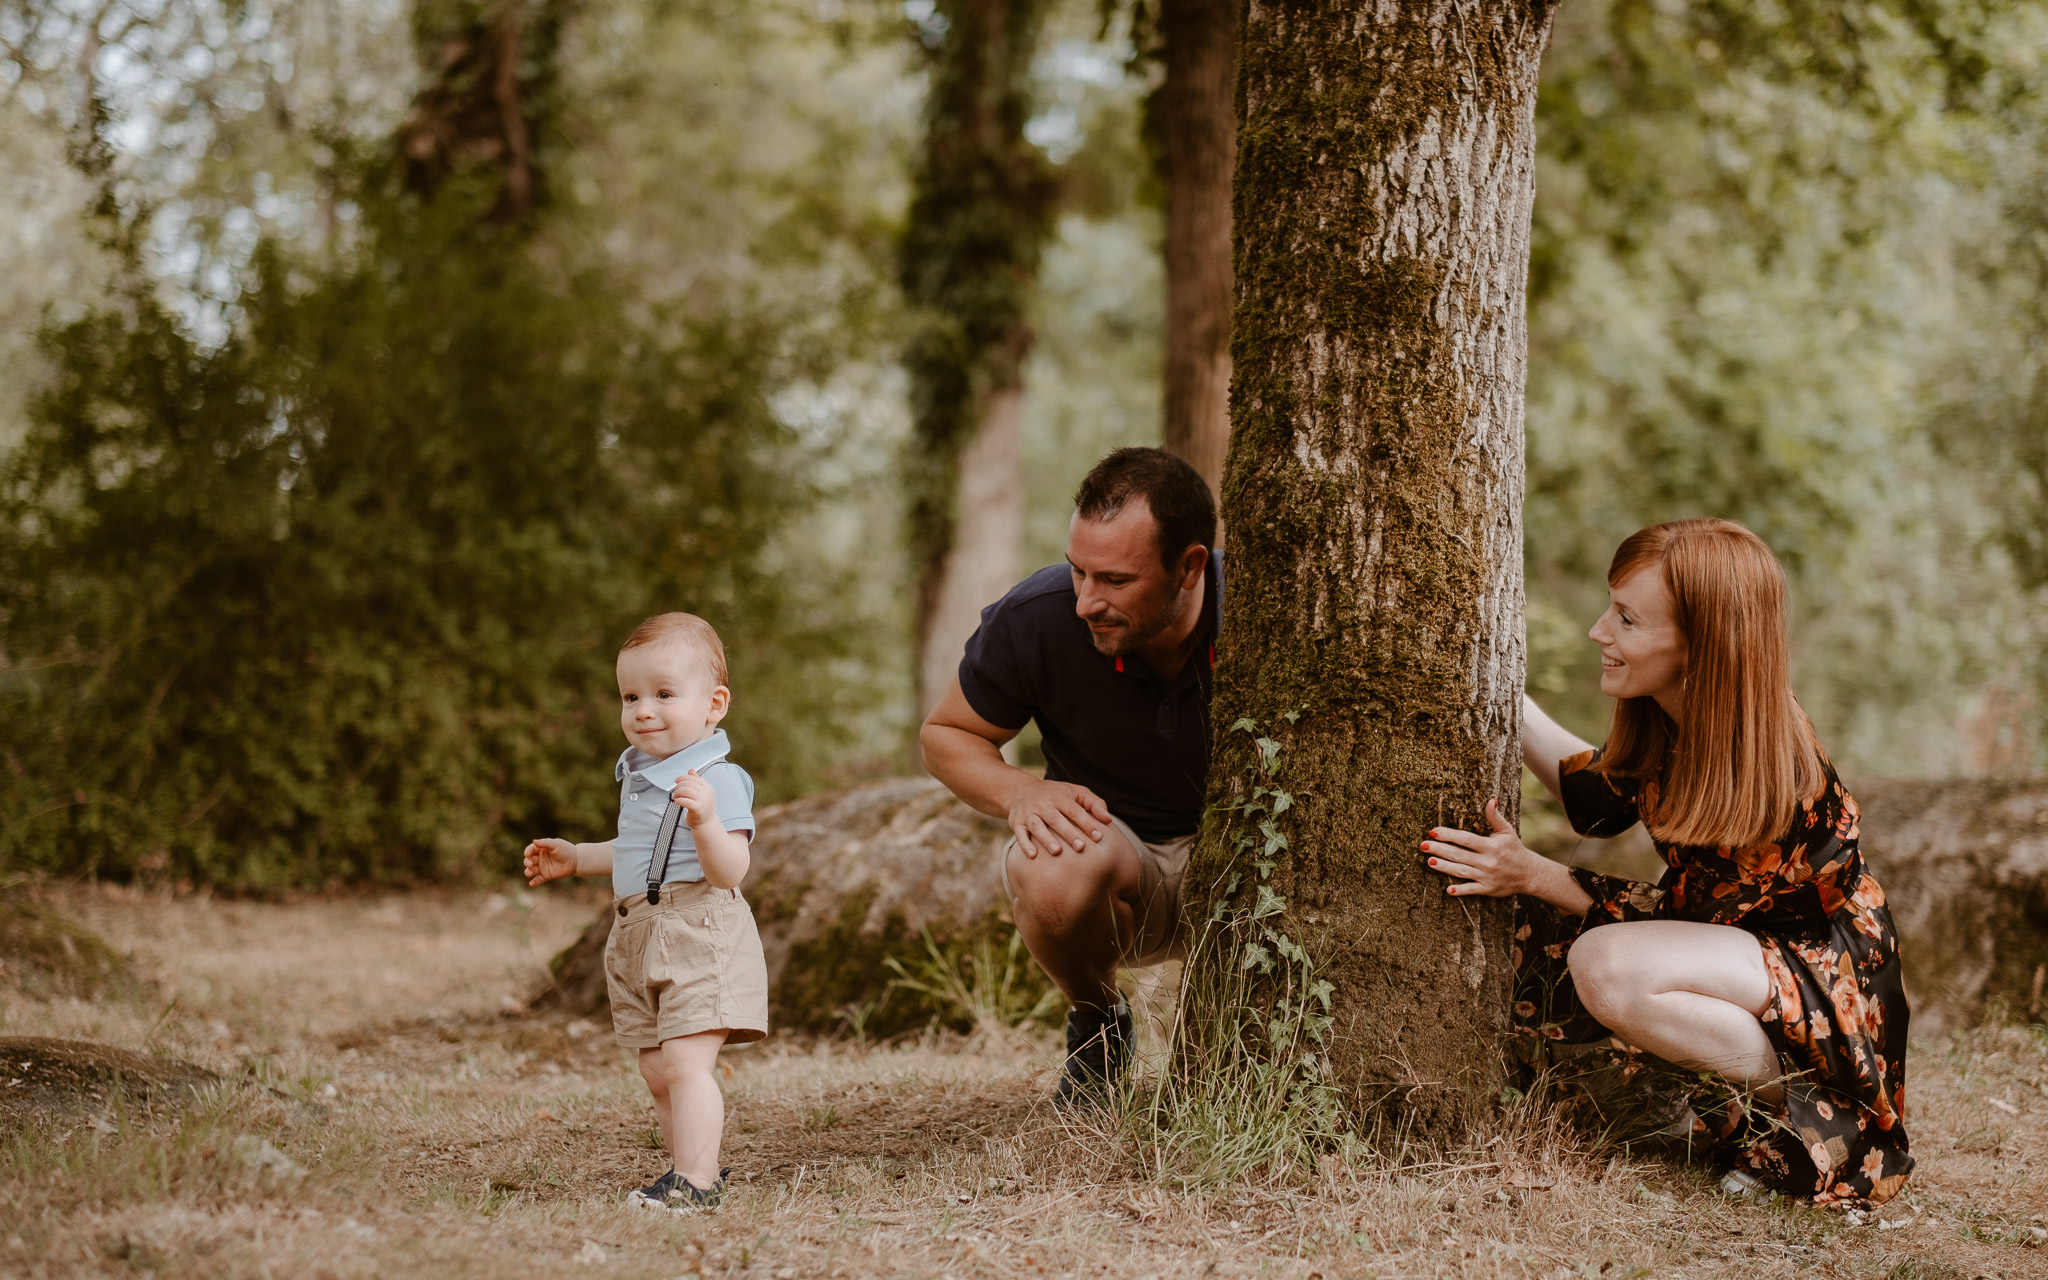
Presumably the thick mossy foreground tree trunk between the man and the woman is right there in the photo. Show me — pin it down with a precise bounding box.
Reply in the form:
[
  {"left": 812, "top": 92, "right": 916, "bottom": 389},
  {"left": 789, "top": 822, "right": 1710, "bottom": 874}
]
[{"left": 1192, "top": 0, "right": 1550, "bottom": 1137}]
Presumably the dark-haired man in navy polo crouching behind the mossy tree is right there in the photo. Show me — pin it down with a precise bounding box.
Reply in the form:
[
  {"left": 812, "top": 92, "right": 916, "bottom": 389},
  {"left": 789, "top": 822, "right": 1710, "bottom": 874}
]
[{"left": 920, "top": 449, "right": 1223, "bottom": 1106}]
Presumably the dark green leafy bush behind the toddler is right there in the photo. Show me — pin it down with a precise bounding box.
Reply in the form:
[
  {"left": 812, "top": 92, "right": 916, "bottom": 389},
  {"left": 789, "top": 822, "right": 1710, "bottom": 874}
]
[{"left": 0, "top": 193, "right": 815, "bottom": 889}]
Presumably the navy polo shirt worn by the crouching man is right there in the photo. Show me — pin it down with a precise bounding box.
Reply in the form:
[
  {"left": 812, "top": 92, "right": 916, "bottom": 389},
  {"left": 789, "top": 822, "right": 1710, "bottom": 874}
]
[{"left": 961, "top": 551, "right": 1223, "bottom": 844}]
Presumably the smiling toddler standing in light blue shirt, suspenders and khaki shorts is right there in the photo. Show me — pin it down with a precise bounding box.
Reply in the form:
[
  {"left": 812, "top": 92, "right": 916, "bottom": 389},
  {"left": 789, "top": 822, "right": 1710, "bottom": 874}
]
[{"left": 526, "top": 612, "right": 768, "bottom": 1210}]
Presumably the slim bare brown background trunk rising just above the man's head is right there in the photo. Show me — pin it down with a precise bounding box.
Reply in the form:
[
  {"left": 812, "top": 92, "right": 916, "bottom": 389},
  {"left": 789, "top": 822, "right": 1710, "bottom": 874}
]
[{"left": 1159, "top": 0, "right": 1237, "bottom": 499}]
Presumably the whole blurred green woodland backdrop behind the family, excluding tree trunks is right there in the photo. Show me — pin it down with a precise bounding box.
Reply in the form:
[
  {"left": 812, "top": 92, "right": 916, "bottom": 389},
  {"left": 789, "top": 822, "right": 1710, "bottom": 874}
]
[{"left": 0, "top": 0, "right": 2048, "bottom": 891}]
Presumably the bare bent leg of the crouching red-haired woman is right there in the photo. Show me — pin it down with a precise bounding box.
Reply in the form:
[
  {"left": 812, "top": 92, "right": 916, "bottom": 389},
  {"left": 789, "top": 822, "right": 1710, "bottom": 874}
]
[{"left": 1567, "top": 920, "right": 1784, "bottom": 1102}]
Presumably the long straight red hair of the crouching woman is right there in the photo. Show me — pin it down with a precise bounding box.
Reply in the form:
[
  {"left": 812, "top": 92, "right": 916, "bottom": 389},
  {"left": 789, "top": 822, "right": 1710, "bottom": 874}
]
[{"left": 1597, "top": 520, "right": 1827, "bottom": 846}]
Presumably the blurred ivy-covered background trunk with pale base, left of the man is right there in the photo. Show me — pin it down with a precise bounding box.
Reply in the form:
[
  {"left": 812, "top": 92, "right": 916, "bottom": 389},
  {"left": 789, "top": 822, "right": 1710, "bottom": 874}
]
[{"left": 903, "top": 0, "right": 1055, "bottom": 715}]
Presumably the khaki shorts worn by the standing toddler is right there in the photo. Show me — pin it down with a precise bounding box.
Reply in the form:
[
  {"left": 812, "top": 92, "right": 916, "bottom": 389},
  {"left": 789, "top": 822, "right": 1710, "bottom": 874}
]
[{"left": 604, "top": 881, "right": 768, "bottom": 1049}]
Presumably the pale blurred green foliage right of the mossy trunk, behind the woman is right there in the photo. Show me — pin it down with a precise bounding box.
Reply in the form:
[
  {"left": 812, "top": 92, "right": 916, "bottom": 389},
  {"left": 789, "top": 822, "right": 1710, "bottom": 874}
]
[{"left": 1526, "top": 0, "right": 2048, "bottom": 776}]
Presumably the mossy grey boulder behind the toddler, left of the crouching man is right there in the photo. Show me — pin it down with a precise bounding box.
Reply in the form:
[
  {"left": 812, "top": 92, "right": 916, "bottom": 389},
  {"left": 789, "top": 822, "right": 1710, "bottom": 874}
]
[{"left": 532, "top": 778, "right": 1019, "bottom": 1034}]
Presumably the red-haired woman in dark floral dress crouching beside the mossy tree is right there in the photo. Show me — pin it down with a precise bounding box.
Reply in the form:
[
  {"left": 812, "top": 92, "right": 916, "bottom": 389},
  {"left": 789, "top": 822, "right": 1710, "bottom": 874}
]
[{"left": 1421, "top": 520, "right": 1913, "bottom": 1208}]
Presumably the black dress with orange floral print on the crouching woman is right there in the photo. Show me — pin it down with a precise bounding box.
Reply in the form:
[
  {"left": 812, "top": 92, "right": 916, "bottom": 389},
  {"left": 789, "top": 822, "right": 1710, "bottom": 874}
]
[{"left": 1516, "top": 752, "right": 1913, "bottom": 1208}]
